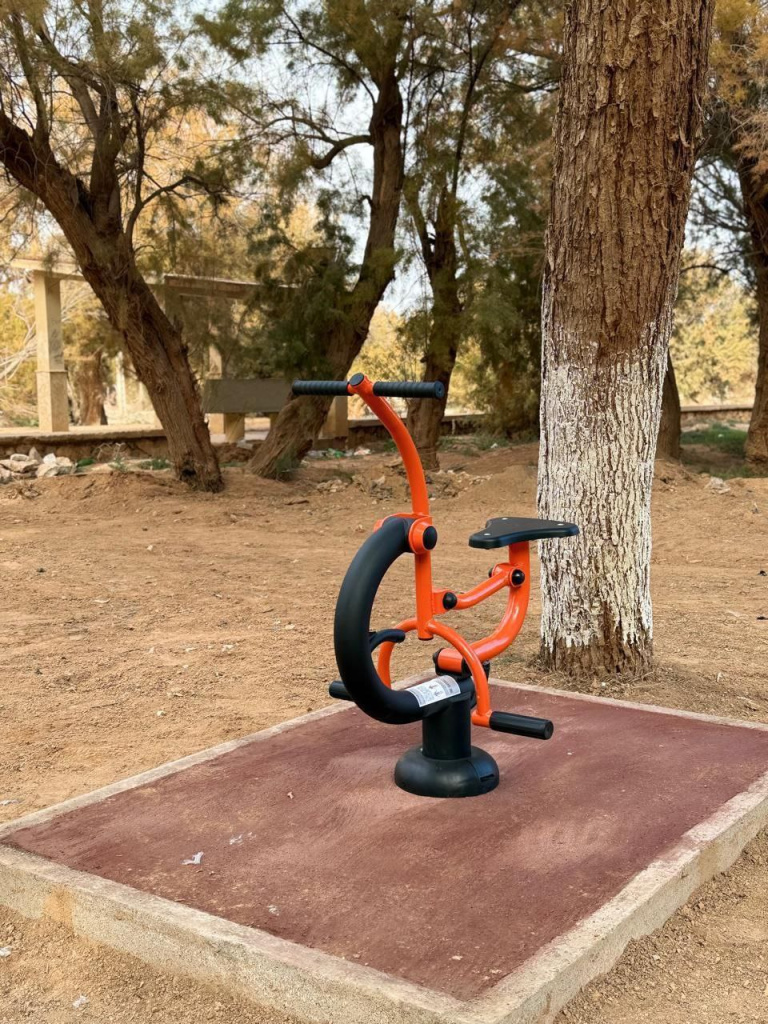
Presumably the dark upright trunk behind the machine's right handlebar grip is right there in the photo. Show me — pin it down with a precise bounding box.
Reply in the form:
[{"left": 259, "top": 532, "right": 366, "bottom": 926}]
[{"left": 408, "top": 188, "right": 463, "bottom": 469}]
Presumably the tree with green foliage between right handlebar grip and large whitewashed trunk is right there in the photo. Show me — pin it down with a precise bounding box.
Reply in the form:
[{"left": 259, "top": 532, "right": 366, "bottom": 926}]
[{"left": 404, "top": 0, "right": 559, "bottom": 468}]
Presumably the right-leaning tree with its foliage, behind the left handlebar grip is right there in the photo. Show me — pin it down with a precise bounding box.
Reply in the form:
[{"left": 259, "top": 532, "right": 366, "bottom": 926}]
[{"left": 201, "top": 0, "right": 411, "bottom": 476}]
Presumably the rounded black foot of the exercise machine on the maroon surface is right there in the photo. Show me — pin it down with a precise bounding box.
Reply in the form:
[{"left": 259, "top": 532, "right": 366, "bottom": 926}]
[{"left": 394, "top": 746, "right": 499, "bottom": 797}]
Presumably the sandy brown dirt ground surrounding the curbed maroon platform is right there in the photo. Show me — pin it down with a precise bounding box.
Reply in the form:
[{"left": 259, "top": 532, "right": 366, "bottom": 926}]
[{"left": 0, "top": 443, "right": 768, "bottom": 1024}]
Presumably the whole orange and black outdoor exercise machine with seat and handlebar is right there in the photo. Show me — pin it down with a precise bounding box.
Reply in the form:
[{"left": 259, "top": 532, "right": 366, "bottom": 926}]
[{"left": 293, "top": 374, "right": 579, "bottom": 797}]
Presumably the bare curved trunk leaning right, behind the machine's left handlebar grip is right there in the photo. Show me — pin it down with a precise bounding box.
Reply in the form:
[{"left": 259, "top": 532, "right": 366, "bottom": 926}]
[{"left": 250, "top": 67, "right": 402, "bottom": 477}]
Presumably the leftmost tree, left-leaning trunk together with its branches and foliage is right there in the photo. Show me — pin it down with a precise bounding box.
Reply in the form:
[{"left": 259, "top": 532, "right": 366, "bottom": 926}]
[{"left": 0, "top": 0, "right": 228, "bottom": 490}]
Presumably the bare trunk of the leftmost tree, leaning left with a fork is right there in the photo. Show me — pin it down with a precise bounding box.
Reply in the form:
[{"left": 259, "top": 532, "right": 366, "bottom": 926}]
[{"left": 0, "top": 112, "right": 223, "bottom": 490}]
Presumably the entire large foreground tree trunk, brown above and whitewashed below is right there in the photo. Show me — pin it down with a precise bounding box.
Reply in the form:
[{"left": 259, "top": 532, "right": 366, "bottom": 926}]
[{"left": 539, "top": 0, "right": 712, "bottom": 677}]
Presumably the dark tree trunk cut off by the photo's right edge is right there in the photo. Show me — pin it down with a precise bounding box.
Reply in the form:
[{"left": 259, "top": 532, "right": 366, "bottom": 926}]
[{"left": 738, "top": 155, "right": 768, "bottom": 468}]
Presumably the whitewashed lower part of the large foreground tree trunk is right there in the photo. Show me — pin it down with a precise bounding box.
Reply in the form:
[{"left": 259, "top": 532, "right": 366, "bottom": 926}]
[{"left": 539, "top": 316, "right": 670, "bottom": 674}]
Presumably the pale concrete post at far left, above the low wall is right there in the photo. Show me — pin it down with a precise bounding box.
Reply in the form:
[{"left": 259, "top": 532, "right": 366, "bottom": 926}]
[{"left": 32, "top": 270, "right": 70, "bottom": 433}]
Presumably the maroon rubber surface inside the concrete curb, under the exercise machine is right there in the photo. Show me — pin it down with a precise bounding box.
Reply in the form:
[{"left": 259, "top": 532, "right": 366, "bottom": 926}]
[{"left": 5, "top": 688, "right": 768, "bottom": 998}]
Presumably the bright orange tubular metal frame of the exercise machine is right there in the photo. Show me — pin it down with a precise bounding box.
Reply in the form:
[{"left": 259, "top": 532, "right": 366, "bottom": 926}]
[{"left": 349, "top": 377, "right": 530, "bottom": 726}]
